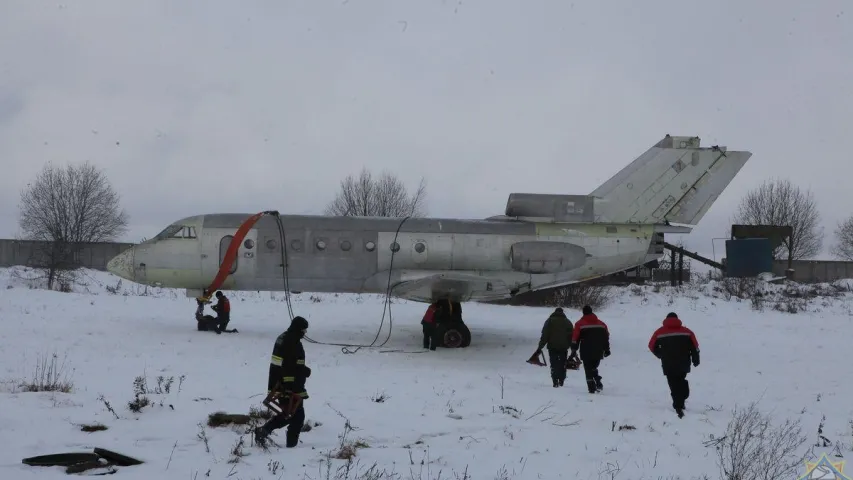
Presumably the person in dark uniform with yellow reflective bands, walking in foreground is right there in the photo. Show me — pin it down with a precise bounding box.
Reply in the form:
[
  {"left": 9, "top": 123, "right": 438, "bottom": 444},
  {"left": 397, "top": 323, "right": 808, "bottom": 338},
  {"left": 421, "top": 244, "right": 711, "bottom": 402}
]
[{"left": 255, "top": 316, "right": 311, "bottom": 448}]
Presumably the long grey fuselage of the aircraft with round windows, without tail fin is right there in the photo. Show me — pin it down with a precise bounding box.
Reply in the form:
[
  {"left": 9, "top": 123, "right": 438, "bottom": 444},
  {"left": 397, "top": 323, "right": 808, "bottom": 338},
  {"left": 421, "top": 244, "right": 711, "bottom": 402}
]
[{"left": 108, "top": 214, "right": 663, "bottom": 301}]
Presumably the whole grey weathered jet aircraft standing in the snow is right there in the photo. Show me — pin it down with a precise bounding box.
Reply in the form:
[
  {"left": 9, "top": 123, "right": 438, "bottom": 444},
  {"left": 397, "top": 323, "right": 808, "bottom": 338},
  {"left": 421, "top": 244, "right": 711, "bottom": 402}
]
[{"left": 107, "top": 135, "right": 752, "bottom": 345}]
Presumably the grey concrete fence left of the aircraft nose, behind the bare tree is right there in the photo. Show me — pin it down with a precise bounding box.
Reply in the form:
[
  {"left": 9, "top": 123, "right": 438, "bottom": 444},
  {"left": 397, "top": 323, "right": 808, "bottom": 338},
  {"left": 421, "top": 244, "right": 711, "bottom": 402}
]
[{"left": 0, "top": 238, "right": 134, "bottom": 271}]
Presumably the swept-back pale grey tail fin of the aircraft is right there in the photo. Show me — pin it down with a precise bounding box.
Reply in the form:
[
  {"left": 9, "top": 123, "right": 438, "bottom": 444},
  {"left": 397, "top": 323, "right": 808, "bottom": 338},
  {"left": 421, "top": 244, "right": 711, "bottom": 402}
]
[{"left": 590, "top": 135, "right": 752, "bottom": 225}]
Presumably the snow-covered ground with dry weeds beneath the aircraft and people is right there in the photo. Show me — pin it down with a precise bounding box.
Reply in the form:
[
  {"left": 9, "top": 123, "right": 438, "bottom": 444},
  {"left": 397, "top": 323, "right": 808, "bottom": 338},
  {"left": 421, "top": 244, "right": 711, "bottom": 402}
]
[{"left": 0, "top": 269, "right": 853, "bottom": 480}]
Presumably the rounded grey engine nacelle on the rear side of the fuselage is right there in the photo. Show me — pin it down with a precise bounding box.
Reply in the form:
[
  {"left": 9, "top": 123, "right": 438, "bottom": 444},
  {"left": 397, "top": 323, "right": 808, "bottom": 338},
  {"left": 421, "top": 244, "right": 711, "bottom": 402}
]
[{"left": 509, "top": 242, "right": 586, "bottom": 273}]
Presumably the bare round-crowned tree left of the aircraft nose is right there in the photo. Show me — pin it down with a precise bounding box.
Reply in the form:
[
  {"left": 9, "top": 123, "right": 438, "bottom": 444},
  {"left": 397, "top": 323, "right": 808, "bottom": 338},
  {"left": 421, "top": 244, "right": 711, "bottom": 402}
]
[{"left": 18, "top": 162, "right": 128, "bottom": 289}]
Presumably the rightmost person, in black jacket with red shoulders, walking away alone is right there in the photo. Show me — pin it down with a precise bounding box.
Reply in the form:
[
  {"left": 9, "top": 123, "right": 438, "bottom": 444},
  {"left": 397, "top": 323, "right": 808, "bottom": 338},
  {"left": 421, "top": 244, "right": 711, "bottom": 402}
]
[{"left": 649, "top": 312, "right": 699, "bottom": 418}]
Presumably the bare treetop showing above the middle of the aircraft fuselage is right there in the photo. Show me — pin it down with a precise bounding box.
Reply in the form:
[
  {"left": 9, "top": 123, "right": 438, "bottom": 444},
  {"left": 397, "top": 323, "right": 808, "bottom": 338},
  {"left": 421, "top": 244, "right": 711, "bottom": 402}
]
[{"left": 325, "top": 169, "right": 426, "bottom": 218}]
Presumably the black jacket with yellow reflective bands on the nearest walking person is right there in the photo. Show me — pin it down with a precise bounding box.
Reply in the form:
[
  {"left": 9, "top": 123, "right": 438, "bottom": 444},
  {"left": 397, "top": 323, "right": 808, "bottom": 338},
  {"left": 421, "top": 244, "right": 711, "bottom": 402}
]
[{"left": 267, "top": 330, "right": 311, "bottom": 398}]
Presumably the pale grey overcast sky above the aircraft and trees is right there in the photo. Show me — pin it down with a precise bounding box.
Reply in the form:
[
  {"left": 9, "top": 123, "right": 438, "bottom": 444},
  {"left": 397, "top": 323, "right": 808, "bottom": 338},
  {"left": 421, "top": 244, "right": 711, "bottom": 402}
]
[{"left": 0, "top": 0, "right": 853, "bottom": 258}]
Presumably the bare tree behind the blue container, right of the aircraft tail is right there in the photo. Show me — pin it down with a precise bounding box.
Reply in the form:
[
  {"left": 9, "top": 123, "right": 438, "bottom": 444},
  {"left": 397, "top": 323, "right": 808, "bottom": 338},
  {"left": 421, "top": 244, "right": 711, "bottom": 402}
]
[{"left": 734, "top": 180, "right": 823, "bottom": 268}]
